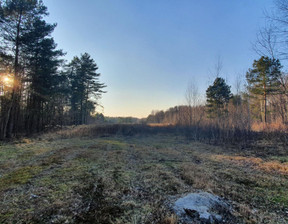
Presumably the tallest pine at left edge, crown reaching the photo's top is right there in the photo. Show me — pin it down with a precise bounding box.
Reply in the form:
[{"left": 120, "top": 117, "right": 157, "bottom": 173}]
[{"left": 0, "top": 0, "right": 47, "bottom": 138}]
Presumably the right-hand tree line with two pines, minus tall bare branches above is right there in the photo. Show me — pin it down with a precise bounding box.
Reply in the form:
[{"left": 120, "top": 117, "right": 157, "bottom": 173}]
[{"left": 147, "top": 56, "right": 288, "bottom": 130}]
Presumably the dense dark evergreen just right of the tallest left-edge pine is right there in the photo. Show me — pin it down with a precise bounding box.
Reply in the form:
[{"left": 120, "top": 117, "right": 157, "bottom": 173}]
[{"left": 22, "top": 19, "right": 63, "bottom": 133}]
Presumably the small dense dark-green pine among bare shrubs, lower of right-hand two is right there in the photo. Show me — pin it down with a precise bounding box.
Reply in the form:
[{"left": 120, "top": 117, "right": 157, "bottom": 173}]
[{"left": 206, "top": 77, "right": 232, "bottom": 117}]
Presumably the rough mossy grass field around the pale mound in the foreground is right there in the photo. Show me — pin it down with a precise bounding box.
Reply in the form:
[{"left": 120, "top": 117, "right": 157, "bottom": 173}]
[{"left": 0, "top": 127, "right": 288, "bottom": 224}]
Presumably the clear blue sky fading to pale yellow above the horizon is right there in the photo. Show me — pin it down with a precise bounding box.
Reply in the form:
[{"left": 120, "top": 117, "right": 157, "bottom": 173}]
[{"left": 44, "top": 0, "right": 273, "bottom": 117}]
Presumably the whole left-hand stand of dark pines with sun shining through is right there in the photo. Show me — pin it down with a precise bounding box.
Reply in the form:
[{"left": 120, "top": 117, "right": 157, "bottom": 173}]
[{"left": 0, "top": 0, "right": 105, "bottom": 139}]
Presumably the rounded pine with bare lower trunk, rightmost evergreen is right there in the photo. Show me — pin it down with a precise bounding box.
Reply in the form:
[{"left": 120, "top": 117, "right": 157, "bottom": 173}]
[{"left": 246, "top": 56, "right": 282, "bottom": 123}]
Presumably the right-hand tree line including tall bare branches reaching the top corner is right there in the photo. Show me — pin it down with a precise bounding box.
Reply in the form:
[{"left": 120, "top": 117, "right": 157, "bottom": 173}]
[{"left": 147, "top": 0, "right": 288, "bottom": 135}]
